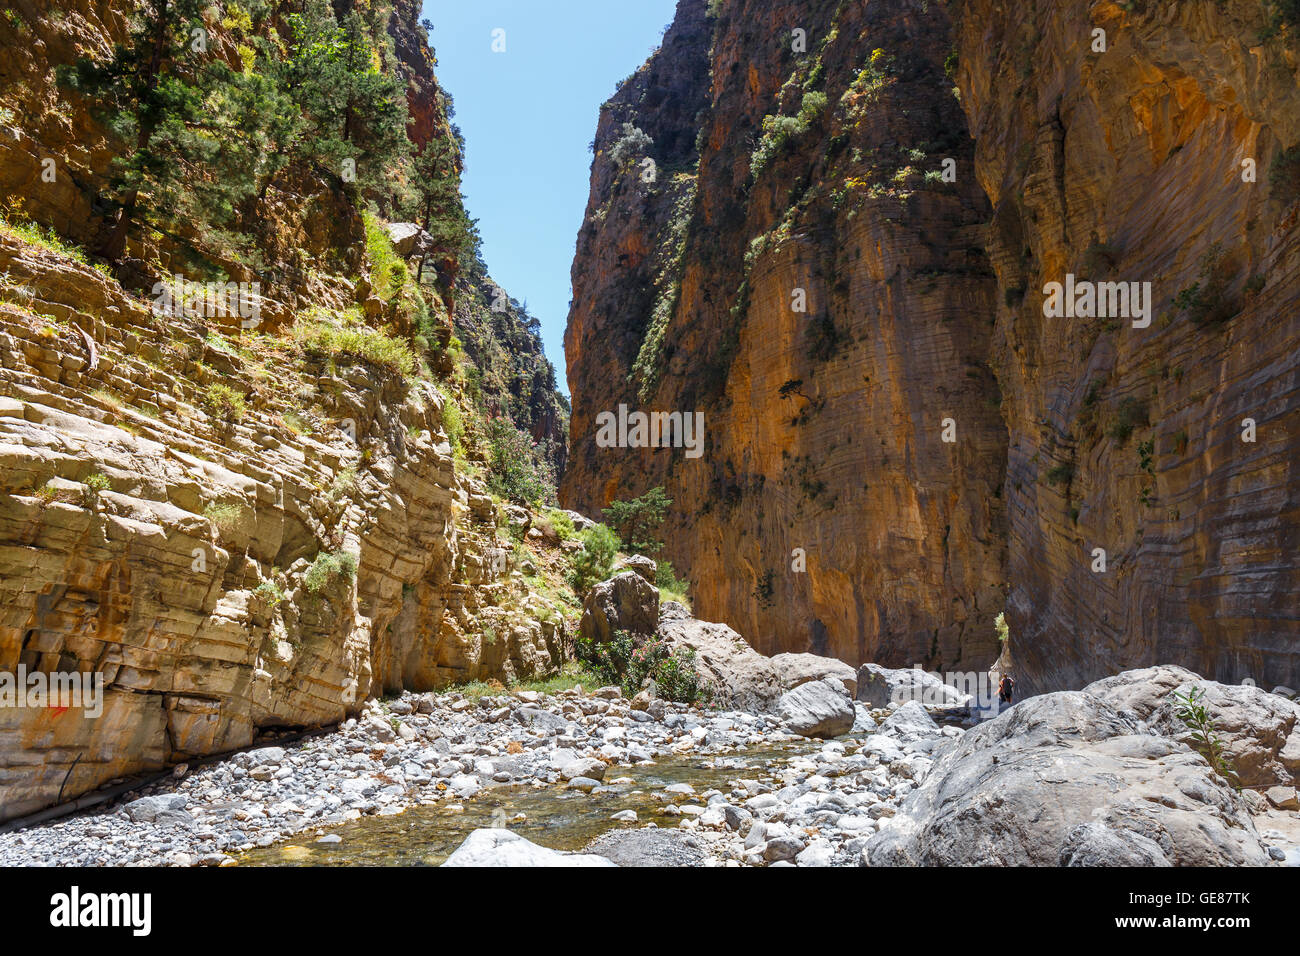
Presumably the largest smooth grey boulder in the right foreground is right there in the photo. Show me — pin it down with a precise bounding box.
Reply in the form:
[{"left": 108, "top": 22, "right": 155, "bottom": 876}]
[{"left": 866, "top": 691, "right": 1268, "bottom": 866}]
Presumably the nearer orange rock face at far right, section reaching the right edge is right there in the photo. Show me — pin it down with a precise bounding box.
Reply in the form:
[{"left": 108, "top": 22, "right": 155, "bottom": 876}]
[{"left": 956, "top": 3, "right": 1300, "bottom": 689}]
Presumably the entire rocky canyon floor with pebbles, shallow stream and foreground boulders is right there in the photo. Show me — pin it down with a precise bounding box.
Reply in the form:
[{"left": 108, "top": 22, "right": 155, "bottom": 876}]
[{"left": 0, "top": 669, "right": 1300, "bottom": 866}]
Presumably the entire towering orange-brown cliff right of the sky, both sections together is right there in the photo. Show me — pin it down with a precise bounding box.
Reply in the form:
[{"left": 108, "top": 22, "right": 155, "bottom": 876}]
[{"left": 562, "top": 0, "right": 1300, "bottom": 692}]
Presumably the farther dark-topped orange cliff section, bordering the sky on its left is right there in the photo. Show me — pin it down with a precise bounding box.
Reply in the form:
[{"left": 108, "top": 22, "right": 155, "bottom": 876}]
[{"left": 562, "top": 1, "right": 1006, "bottom": 670}]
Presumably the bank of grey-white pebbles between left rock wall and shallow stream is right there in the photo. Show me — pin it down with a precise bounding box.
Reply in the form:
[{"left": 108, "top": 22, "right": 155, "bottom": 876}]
[{"left": 0, "top": 687, "right": 904, "bottom": 866}]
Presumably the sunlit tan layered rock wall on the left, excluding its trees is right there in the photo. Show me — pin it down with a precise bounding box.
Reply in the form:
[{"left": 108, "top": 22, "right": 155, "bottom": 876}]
[{"left": 0, "top": 0, "right": 572, "bottom": 819}]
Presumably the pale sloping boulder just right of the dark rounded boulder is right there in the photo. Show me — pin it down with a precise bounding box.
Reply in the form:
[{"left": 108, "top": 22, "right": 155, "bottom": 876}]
[{"left": 657, "top": 606, "right": 785, "bottom": 713}]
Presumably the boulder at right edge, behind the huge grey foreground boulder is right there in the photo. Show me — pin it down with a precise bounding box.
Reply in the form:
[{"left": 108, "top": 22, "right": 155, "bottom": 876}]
[{"left": 1083, "top": 665, "right": 1300, "bottom": 788}]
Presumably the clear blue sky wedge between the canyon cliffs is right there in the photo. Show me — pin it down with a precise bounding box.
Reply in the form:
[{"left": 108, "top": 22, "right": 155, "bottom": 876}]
[{"left": 424, "top": 0, "right": 676, "bottom": 393}]
